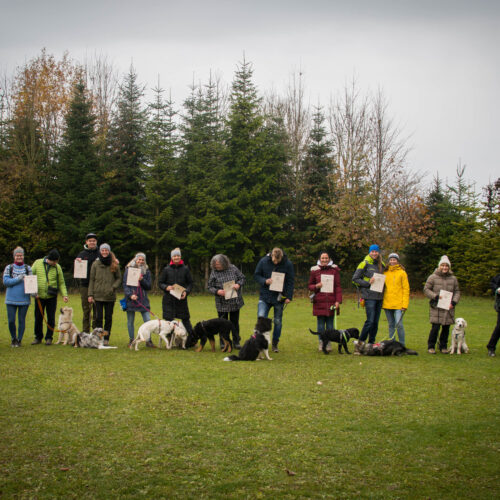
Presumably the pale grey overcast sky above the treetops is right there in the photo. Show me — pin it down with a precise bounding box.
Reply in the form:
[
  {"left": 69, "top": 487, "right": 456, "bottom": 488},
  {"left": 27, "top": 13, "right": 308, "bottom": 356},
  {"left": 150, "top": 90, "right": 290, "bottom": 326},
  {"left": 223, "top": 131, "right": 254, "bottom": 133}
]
[{"left": 0, "top": 0, "right": 500, "bottom": 189}]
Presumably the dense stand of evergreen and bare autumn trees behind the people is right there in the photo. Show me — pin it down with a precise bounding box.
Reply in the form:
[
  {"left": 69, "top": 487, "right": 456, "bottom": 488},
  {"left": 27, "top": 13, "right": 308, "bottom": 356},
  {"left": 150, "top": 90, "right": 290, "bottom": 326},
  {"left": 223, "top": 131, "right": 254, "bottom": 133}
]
[{"left": 0, "top": 50, "right": 500, "bottom": 294}]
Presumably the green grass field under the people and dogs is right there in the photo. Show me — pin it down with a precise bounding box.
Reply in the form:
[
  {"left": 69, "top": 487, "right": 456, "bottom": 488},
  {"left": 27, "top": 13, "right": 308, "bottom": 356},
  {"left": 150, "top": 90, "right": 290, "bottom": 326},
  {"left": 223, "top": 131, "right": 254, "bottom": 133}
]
[{"left": 0, "top": 296, "right": 500, "bottom": 499}]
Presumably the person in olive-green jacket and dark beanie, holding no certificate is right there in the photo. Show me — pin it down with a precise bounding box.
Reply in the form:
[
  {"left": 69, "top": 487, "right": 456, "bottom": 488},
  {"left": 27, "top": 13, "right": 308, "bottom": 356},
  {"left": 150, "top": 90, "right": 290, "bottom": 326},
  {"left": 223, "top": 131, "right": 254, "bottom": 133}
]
[{"left": 88, "top": 243, "right": 122, "bottom": 346}]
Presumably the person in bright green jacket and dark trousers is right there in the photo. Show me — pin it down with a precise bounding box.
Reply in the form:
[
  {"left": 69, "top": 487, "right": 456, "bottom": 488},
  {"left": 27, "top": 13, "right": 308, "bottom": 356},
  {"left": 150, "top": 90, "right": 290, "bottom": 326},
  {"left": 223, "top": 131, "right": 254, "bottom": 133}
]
[{"left": 31, "top": 249, "right": 68, "bottom": 345}]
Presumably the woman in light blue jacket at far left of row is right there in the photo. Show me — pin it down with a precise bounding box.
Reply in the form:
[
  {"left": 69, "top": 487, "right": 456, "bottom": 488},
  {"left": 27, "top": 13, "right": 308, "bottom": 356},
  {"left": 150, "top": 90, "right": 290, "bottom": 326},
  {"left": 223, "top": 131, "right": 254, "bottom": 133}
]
[{"left": 3, "top": 247, "right": 33, "bottom": 347}]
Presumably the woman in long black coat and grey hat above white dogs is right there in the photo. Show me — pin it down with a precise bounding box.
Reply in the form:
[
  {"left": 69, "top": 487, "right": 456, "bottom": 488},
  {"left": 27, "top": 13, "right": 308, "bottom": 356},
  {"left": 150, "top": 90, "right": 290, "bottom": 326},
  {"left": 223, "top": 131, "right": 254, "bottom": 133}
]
[{"left": 158, "top": 248, "right": 194, "bottom": 337}]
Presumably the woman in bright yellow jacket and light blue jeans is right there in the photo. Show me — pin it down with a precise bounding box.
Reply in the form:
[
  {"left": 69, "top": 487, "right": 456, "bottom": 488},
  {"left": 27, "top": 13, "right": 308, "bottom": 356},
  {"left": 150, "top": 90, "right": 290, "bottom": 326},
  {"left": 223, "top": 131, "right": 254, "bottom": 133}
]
[{"left": 382, "top": 253, "right": 410, "bottom": 345}]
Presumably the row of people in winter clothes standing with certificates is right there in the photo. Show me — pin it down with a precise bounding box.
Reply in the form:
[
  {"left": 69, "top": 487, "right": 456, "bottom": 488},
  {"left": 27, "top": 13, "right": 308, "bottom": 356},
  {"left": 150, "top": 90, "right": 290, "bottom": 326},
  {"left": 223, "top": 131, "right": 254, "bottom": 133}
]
[{"left": 3, "top": 233, "right": 500, "bottom": 356}]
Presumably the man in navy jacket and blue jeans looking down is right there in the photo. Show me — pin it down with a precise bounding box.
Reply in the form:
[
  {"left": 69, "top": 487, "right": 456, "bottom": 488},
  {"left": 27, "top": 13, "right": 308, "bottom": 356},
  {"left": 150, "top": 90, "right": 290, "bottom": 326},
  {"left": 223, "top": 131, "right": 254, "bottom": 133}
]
[{"left": 253, "top": 248, "right": 294, "bottom": 352}]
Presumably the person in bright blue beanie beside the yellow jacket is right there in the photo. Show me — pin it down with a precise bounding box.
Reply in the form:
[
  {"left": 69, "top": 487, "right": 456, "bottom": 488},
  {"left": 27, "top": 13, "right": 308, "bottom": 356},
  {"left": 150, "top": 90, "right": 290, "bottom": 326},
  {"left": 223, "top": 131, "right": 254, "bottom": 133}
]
[{"left": 352, "top": 245, "right": 385, "bottom": 344}]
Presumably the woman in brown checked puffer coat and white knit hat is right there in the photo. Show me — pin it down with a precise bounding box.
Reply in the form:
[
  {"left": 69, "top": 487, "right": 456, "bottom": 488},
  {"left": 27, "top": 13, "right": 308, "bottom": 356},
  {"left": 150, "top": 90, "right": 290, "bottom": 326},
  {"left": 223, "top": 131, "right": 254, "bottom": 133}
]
[{"left": 424, "top": 255, "right": 460, "bottom": 354}]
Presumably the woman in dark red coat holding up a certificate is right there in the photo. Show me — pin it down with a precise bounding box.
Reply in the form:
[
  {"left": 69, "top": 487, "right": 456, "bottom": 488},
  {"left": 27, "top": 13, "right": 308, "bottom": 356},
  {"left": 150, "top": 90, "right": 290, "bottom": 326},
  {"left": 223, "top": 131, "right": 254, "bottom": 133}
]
[{"left": 308, "top": 252, "right": 342, "bottom": 351}]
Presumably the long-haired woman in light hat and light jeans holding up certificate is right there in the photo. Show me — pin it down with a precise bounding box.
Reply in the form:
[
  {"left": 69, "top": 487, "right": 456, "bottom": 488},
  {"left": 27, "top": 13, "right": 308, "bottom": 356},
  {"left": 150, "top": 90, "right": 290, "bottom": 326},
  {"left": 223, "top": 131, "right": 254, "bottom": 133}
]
[{"left": 123, "top": 252, "right": 154, "bottom": 347}]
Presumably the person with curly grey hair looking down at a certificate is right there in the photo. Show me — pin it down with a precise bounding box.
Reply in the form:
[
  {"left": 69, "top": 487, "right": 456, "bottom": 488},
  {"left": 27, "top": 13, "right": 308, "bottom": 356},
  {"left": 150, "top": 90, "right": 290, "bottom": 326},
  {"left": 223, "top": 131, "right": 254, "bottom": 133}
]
[{"left": 207, "top": 253, "right": 245, "bottom": 349}]
